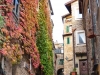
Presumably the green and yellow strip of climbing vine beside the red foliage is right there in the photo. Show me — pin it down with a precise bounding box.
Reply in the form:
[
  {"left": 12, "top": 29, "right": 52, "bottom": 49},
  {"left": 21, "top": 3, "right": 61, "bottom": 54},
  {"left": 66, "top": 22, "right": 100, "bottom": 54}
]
[{"left": 37, "top": 0, "right": 53, "bottom": 75}]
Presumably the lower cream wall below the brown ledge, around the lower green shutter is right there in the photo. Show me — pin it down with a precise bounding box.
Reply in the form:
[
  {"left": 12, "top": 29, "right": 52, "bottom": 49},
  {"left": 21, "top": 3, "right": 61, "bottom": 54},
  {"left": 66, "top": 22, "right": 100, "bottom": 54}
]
[{"left": 64, "top": 35, "right": 74, "bottom": 75}]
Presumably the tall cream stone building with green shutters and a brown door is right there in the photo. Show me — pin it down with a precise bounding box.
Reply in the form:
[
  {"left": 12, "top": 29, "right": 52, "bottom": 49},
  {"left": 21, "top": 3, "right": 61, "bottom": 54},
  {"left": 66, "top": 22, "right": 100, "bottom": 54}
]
[{"left": 62, "top": 0, "right": 87, "bottom": 75}]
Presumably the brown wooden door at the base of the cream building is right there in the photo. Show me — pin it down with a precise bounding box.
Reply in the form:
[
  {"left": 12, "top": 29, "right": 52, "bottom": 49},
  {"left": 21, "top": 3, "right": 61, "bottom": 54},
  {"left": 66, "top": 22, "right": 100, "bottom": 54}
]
[{"left": 79, "top": 60, "right": 88, "bottom": 75}]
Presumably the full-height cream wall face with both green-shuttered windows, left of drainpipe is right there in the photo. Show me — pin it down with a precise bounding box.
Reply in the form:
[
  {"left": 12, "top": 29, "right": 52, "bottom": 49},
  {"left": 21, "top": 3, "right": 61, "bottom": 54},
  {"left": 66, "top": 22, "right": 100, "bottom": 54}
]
[{"left": 63, "top": 15, "right": 74, "bottom": 75}]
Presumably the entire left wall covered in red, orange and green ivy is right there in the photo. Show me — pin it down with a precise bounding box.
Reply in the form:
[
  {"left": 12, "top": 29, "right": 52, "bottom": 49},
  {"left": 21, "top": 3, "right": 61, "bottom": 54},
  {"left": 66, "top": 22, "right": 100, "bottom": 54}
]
[{"left": 0, "top": 0, "right": 53, "bottom": 75}]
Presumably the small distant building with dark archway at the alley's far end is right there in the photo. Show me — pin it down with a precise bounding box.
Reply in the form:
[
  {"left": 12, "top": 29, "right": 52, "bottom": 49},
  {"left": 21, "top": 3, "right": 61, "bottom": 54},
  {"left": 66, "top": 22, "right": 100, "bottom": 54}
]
[{"left": 53, "top": 42, "right": 64, "bottom": 75}]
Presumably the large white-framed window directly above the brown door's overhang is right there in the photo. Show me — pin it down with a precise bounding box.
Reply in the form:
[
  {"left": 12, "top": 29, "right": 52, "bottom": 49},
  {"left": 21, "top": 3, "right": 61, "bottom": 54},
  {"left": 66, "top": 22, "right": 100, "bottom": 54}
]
[{"left": 76, "top": 30, "right": 86, "bottom": 45}]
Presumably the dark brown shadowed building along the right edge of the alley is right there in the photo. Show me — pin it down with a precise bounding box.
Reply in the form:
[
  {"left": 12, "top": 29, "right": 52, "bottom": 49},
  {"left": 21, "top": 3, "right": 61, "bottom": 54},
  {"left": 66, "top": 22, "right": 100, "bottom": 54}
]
[{"left": 79, "top": 0, "right": 100, "bottom": 75}]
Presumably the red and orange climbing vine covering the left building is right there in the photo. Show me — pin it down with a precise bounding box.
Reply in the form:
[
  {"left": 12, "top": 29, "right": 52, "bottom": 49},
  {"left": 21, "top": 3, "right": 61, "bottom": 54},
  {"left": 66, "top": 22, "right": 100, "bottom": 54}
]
[{"left": 0, "top": 0, "right": 40, "bottom": 68}]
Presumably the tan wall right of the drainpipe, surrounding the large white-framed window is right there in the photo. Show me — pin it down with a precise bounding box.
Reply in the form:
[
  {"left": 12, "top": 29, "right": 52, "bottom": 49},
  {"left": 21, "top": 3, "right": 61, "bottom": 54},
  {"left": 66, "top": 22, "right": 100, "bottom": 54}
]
[{"left": 71, "top": 1, "right": 87, "bottom": 74}]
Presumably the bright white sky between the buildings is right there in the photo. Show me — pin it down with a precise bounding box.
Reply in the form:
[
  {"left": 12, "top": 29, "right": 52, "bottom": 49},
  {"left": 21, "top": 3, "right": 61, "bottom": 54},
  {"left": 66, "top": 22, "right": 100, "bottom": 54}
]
[{"left": 51, "top": 0, "right": 70, "bottom": 43}]
